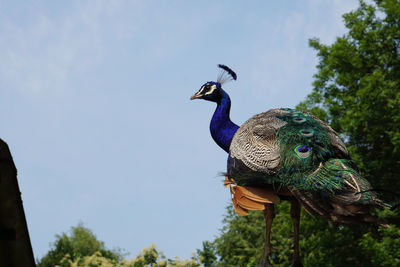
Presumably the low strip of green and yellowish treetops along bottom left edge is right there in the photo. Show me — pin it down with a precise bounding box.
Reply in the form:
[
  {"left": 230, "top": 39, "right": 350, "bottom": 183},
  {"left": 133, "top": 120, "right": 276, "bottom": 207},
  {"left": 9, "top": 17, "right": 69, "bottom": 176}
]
[{"left": 37, "top": 224, "right": 200, "bottom": 267}]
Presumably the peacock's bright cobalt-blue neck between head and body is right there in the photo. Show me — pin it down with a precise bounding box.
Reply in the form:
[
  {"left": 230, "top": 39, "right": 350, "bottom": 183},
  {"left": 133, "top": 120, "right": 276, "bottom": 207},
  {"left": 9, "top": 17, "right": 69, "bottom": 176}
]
[{"left": 210, "top": 89, "right": 239, "bottom": 153}]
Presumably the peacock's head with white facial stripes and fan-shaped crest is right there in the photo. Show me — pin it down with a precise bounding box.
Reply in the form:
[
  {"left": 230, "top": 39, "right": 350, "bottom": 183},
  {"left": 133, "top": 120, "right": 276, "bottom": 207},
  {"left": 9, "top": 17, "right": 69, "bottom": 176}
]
[{"left": 190, "top": 64, "right": 237, "bottom": 103}]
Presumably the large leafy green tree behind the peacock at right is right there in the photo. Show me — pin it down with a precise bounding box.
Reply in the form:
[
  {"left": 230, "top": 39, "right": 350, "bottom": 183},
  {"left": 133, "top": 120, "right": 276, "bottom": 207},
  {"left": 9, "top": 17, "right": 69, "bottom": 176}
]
[{"left": 200, "top": 0, "right": 400, "bottom": 267}]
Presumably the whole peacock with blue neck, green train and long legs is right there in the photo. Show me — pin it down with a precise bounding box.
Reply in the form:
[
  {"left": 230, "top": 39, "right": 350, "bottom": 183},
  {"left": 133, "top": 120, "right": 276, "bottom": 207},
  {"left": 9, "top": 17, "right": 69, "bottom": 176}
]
[{"left": 190, "top": 65, "right": 388, "bottom": 266}]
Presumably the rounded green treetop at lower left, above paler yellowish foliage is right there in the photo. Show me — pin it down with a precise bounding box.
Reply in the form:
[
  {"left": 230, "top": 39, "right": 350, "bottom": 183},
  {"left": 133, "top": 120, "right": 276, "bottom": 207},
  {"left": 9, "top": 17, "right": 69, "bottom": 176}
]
[{"left": 37, "top": 224, "right": 122, "bottom": 267}]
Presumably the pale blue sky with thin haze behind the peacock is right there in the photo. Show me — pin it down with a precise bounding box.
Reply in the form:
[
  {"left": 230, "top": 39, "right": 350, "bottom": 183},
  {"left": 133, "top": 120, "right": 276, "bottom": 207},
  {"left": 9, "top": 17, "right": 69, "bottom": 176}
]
[{"left": 0, "top": 0, "right": 358, "bottom": 258}]
